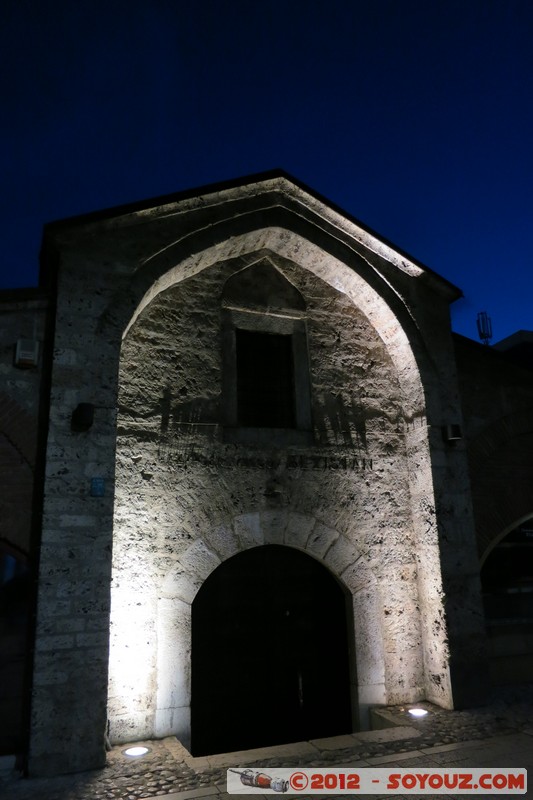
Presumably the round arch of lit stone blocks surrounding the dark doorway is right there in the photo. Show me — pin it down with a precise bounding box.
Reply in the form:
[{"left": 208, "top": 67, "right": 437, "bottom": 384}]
[{"left": 109, "top": 510, "right": 387, "bottom": 745}]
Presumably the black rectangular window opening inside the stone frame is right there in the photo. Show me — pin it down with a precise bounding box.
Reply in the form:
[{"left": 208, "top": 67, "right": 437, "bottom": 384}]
[{"left": 235, "top": 328, "right": 296, "bottom": 428}]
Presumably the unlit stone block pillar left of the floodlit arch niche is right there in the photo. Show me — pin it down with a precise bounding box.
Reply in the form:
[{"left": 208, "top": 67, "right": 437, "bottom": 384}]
[{"left": 28, "top": 262, "right": 116, "bottom": 775}]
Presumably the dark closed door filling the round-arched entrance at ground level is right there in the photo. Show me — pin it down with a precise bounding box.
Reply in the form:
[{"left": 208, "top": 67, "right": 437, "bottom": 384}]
[{"left": 191, "top": 545, "right": 352, "bottom": 756}]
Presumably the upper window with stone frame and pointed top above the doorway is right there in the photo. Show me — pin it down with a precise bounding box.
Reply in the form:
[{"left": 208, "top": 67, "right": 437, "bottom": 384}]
[{"left": 221, "top": 261, "right": 312, "bottom": 447}]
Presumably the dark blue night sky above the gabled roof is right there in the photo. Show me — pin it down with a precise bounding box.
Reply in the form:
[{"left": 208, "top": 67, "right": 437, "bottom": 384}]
[{"left": 0, "top": 0, "right": 533, "bottom": 341}]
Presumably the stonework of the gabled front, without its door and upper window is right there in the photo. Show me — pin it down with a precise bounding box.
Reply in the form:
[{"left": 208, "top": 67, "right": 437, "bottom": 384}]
[{"left": 29, "top": 176, "right": 484, "bottom": 774}]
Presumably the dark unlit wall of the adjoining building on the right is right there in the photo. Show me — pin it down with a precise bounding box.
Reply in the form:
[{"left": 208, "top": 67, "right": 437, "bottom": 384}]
[{"left": 455, "top": 332, "right": 533, "bottom": 683}]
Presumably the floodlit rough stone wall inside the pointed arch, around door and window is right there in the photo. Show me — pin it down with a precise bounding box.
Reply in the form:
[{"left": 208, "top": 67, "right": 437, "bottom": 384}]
[{"left": 109, "top": 259, "right": 424, "bottom": 741}]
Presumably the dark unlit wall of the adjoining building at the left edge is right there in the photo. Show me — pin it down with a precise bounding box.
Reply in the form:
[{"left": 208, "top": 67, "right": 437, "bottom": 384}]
[{"left": 0, "top": 289, "right": 48, "bottom": 754}]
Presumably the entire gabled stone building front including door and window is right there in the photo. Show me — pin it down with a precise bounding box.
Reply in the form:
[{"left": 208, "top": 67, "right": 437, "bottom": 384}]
[{"left": 0, "top": 173, "right": 533, "bottom": 774}]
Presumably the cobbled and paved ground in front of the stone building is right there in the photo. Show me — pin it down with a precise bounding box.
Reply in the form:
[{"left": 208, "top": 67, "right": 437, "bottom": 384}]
[{"left": 0, "top": 684, "right": 533, "bottom": 800}]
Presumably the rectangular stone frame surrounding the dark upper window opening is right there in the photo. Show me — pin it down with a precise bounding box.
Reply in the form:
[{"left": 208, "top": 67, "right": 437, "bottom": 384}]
[{"left": 222, "top": 307, "right": 313, "bottom": 447}]
